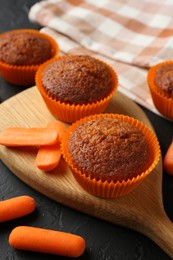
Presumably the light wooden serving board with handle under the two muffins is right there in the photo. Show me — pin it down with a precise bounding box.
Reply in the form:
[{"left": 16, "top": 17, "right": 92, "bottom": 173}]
[{"left": 0, "top": 87, "right": 173, "bottom": 258}]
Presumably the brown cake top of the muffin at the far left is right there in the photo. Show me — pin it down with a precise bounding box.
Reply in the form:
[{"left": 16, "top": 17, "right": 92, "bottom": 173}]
[{"left": 0, "top": 30, "right": 52, "bottom": 65}]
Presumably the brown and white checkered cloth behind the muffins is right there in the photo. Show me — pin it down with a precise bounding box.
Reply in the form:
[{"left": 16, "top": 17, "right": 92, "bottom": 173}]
[{"left": 29, "top": 0, "right": 173, "bottom": 117}]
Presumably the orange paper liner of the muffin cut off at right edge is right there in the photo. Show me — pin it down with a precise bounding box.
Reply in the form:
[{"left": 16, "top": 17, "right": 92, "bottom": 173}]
[{"left": 147, "top": 61, "right": 173, "bottom": 120}]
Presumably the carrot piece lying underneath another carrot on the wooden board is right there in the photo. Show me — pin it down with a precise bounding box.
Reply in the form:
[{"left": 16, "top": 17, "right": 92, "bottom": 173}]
[{"left": 35, "top": 120, "right": 65, "bottom": 171}]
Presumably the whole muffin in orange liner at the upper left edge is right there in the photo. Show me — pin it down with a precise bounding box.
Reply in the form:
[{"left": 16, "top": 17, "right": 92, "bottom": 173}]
[{"left": 0, "top": 29, "right": 59, "bottom": 85}]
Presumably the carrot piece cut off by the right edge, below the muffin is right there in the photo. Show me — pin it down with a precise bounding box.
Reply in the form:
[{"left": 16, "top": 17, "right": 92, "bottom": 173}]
[{"left": 163, "top": 140, "right": 173, "bottom": 175}]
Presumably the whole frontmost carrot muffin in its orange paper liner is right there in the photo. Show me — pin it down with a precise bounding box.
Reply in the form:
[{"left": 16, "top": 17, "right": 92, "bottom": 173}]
[{"left": 62, "top": 114, "right": 159, "bottom": 197}]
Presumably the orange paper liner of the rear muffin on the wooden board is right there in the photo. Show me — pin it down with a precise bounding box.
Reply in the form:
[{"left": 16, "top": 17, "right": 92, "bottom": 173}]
[{"left": 36, "top": 55, "right": 118, "bottom": 123}]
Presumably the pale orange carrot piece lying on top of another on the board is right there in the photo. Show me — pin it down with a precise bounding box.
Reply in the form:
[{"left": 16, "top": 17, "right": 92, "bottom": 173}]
[{"left": 0, "top": 127, "right": 59, "bottom": 146}]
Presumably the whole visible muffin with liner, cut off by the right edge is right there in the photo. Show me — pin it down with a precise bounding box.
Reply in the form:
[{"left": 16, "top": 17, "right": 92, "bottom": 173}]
[{"left": 148, "top": 61, "right": 173, "bottom": 119}]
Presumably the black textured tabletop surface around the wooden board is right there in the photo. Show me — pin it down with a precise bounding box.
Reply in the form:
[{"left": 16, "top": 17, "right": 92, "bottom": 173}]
[{"left": 0, "top": 0, "right": 173, "bottom": 260}]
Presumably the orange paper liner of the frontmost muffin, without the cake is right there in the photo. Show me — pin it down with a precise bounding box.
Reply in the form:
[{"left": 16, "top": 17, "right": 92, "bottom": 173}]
[{"left": 61, "top": 114, "right": 160, "bottom": 198}]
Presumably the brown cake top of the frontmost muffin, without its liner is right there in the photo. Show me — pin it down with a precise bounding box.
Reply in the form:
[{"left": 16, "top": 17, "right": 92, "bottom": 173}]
[{"left": 68, "top": 118, "right": 149, "bottom": 182}]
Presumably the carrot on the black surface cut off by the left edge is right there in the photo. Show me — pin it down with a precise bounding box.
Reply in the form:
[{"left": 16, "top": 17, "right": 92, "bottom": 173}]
[{"left": 0, "top": 196, "right": 36, "bottom": 222}]
